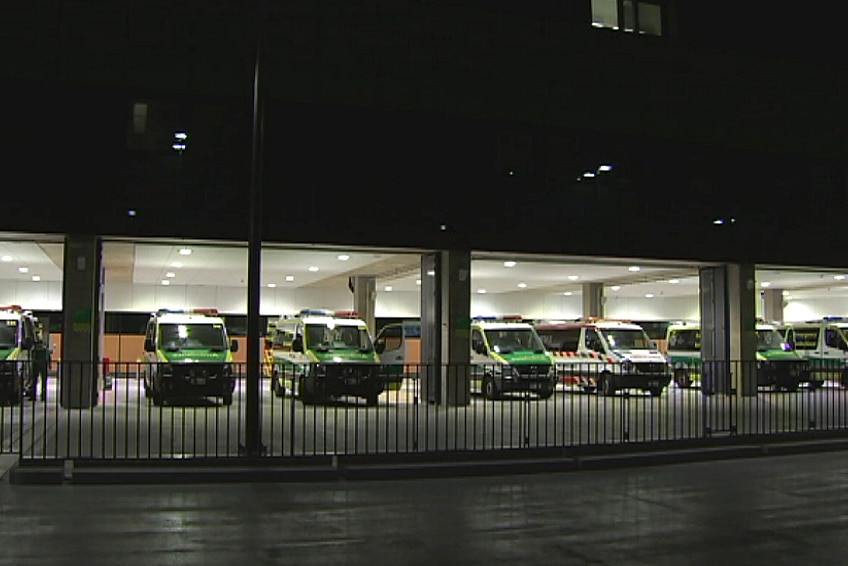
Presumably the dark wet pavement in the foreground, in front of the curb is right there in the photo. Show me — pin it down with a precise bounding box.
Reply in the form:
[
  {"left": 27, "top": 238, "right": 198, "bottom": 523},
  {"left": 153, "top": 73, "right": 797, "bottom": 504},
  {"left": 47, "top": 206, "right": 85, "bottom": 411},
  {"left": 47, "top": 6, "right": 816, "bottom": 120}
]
[{"left": 0, "top": 451, "right": 848, "bottom": 566}]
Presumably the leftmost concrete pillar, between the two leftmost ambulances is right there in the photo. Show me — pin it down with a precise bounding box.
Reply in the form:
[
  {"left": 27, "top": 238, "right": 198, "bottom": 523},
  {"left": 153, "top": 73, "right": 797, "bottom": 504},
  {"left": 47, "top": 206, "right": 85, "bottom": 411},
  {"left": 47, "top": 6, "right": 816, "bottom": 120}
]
[{"left": 59, "top": 235, "right": 104, "bottom": 409}]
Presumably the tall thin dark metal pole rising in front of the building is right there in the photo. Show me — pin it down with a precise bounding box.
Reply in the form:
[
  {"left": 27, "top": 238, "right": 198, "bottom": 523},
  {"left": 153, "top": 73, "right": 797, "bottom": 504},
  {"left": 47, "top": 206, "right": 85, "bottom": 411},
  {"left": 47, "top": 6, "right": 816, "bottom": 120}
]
[{"left": 244, "top": 0, "right": 267, "bottom": 456}]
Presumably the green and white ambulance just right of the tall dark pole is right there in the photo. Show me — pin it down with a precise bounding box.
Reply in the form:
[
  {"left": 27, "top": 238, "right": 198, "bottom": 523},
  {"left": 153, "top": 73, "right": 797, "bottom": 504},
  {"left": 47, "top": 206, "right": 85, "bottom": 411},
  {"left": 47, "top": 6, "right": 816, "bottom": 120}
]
[{"left": 271, "top": 309, "right": 384, "bottom": 405}]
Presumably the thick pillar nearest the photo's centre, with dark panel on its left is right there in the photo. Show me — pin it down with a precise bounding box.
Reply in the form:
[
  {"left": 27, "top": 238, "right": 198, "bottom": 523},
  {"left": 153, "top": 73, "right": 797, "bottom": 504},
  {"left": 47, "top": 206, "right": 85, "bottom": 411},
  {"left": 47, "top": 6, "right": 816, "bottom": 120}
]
[{"left": 421, "top": 250, "right": 471, "bottom": 405}]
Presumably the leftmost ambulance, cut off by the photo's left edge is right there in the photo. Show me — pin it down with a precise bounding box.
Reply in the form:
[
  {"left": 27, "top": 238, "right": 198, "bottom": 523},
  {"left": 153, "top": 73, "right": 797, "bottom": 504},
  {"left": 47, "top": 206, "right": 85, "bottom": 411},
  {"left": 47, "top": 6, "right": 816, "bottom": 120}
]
[{"left": 0, "top": 305, "right": 36, "bottom": 404}]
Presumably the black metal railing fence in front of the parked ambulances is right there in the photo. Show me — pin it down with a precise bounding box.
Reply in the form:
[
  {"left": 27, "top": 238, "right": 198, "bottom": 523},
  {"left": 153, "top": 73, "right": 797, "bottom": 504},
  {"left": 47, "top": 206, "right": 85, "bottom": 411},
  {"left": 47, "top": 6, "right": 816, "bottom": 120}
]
[{"left": 0, "top": 362, "right": 848, "bottom": 460}]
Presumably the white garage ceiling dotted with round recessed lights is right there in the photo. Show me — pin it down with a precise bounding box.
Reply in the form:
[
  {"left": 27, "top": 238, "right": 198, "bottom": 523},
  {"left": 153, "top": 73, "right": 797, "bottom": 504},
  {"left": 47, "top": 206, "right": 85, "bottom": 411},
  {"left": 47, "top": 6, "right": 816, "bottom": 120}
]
[{"left": 0, "top": 238, "right": 848, "bottom": 304}]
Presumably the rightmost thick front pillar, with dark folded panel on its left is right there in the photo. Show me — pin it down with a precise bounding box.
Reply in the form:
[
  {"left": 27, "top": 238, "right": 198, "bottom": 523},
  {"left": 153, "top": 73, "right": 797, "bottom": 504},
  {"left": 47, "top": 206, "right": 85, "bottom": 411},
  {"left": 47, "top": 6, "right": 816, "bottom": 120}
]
[{"left": 700, "top": 264, "right": 757, "bottom": 396}]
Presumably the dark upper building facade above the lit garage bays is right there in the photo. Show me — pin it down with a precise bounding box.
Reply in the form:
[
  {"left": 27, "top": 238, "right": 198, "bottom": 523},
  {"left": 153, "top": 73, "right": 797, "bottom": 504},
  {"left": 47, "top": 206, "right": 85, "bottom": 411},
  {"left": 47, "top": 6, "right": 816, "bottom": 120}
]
[{"left": 0, "top": 0, "right": 848, "bottom": 266}]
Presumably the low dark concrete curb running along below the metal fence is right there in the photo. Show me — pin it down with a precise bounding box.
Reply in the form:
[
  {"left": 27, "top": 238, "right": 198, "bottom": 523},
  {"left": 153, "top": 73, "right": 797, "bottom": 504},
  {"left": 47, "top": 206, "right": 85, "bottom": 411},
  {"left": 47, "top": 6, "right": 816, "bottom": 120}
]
[{"left": 8, "top": 438, "right": 848, "bottom": 485}]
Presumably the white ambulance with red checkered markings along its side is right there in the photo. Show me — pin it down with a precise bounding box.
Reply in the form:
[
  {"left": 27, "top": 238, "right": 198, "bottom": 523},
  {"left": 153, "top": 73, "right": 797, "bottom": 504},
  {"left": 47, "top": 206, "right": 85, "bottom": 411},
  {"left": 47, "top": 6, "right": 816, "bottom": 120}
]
[{"left": 536, "top": 318, "right": 671, "bottom": 397}]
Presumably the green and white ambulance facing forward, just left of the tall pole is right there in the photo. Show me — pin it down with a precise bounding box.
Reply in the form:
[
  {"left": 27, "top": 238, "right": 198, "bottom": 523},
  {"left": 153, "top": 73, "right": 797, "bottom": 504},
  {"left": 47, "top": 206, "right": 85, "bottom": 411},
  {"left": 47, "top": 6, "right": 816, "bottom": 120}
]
[{"left": 141, "top": 309, "right": 238, "bottom": 405}]
